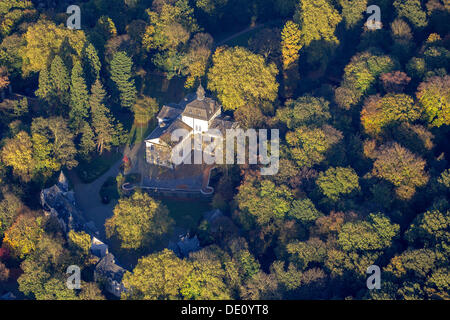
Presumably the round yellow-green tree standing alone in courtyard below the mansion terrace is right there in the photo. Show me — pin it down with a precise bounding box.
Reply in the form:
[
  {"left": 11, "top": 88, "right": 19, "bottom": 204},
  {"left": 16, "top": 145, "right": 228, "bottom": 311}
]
[{"left": 105, "top": 192, "right": 173, "bottom": 249}]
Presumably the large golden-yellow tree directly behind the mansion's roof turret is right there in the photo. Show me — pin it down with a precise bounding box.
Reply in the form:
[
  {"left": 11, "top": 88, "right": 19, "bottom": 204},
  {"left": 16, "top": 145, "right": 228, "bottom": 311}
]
[{"left": 208, "top": 47, "right": 278, "bottom": 110}]
